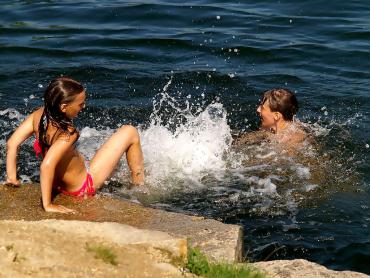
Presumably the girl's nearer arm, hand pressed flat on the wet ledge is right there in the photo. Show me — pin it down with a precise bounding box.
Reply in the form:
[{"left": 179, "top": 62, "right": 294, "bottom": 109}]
[{"left": 40, "top": 133, "right": 78, "bottom": 213}]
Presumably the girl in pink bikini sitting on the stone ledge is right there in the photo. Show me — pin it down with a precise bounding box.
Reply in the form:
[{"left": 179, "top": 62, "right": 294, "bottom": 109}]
[{"left": 6, "top": 77, "right": 144, "bottom": 213}]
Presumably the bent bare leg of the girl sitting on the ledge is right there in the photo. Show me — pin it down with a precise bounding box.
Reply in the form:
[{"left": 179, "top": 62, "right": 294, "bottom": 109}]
[{"left": 90, "top": 125, "right": 144, "bottom": 189}]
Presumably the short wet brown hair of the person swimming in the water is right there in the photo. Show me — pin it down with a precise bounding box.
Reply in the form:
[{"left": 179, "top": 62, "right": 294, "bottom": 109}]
[{"left": 261, "top": 89, "right": 298, "bottom": 121}]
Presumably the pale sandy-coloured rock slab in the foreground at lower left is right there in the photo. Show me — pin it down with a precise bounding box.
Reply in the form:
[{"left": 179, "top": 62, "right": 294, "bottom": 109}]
[{"left": 0, "top": 220, "right": 190, "bottom": 277}]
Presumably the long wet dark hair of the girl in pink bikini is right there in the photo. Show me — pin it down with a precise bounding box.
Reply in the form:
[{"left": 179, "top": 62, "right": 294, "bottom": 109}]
[{"left": 39, "top": 77, "right": 84, "bottom": 154}]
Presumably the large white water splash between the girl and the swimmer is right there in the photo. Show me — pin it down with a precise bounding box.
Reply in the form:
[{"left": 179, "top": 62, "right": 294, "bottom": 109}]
[{"left": 141, "top": 79, "right": 232, "bottom": 186}]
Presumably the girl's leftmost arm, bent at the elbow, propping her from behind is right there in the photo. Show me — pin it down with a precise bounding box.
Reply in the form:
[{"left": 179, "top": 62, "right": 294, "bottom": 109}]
[{"left": 6, "top": 113, "right": 35, "bottom": 186}]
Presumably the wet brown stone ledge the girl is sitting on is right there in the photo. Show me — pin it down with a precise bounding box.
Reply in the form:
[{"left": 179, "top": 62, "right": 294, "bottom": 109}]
[{"left": 0, "top": 184, "right": 243, "bottom": 262}]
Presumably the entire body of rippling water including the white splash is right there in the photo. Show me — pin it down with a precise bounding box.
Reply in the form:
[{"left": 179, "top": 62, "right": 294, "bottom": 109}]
[{"left": 0, "top": 1, "right": 370, "bottom": 274}]
